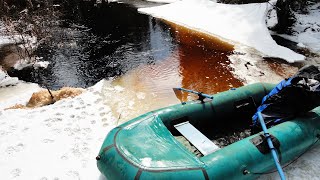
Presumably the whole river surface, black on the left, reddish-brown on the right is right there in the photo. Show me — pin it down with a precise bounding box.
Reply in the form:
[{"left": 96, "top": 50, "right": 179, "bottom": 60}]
[{"left": 9, "top": 2, "right": 242, "bottom": 100}]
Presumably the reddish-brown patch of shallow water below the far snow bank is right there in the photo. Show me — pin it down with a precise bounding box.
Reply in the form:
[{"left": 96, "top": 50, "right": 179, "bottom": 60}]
[{"left": 167, "top": 22, "right": 242, "bottom": 101}]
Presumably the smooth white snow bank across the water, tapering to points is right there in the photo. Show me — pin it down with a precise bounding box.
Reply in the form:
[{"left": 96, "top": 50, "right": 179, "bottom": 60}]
[{"left": 139, "top": 0, "right": 304, "bottom": 63}]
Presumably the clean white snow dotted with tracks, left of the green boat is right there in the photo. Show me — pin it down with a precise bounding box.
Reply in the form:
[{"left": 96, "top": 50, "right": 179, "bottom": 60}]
[{"left": 0, "top": 81, "right": 115, "bottom": 179}]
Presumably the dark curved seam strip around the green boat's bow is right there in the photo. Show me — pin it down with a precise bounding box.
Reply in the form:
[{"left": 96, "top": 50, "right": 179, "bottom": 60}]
[{"left": 113, "top": 127, "right": 205, "bottom": 172}]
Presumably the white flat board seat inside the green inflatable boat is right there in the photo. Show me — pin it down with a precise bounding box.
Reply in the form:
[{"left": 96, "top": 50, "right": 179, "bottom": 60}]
[{"left": 174, "top": 121, "right": 220, "bottom": 156}]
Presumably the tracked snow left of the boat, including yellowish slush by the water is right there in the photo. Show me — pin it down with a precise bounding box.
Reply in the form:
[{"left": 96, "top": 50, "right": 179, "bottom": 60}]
[{"left": 0, "top": 75, "right": 179, "bottom": 179}]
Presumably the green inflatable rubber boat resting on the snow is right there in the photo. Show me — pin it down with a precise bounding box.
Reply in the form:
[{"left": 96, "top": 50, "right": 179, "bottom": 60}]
[{"left": 96, "top": 83, "right": 320, "bottom": 180}]
